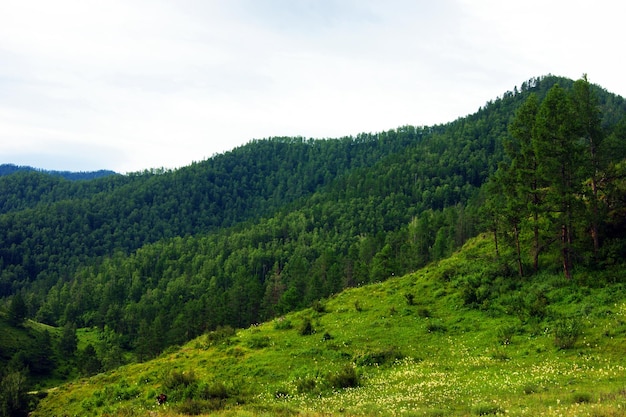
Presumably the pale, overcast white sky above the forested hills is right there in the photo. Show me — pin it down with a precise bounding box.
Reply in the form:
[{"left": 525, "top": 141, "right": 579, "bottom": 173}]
[{"left": 0, "top": 0, "right": 626, "bottom": 173}]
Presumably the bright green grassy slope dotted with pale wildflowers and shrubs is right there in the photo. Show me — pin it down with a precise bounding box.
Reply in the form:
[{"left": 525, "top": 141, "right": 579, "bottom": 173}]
[{"left": 33, "top": 237, "right": 626, "bottom": 417}]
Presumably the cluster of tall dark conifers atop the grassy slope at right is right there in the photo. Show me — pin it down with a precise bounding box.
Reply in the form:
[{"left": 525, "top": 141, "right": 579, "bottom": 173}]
[{"left": 485, "top": 76, "right": 626, "bottom": 279}]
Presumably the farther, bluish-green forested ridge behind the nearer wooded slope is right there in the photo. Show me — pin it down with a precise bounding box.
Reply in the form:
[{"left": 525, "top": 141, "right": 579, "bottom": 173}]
[{"left": 0, "top": 135, "right": 422, "bottom": 297}]
